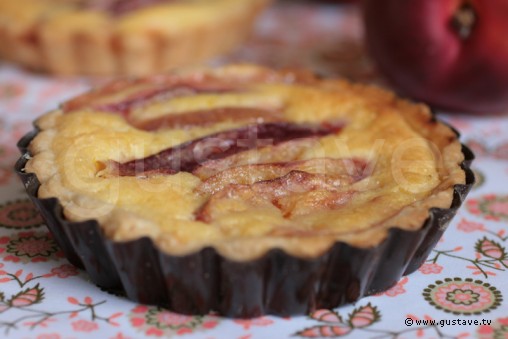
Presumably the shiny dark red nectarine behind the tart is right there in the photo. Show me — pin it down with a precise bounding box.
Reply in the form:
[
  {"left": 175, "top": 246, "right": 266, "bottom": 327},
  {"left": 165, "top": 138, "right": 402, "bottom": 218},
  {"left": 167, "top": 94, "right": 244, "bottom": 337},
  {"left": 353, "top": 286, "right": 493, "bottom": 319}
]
[{"left": 363, "top": 0, "right": 508, "bottom": 113}]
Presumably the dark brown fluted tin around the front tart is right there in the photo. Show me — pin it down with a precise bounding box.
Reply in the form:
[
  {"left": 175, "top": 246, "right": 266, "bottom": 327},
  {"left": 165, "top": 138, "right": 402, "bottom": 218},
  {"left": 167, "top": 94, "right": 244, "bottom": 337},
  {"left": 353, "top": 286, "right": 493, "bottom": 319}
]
[{"left": 15, "top": 130, "right": 474, "bottom": 318}]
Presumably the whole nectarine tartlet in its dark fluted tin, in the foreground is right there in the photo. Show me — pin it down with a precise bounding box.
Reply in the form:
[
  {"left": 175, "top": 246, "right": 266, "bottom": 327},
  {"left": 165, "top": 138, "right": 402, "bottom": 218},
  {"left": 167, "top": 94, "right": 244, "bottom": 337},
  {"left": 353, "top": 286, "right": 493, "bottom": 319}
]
[{"left": 17, "top": 65, "right": 474, "bottom": 317}]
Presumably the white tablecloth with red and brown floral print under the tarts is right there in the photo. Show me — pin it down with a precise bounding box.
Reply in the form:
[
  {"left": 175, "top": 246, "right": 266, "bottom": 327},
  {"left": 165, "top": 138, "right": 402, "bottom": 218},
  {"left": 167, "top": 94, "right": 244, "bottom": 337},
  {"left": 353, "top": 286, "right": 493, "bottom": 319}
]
[{"left": 0, "top": 1, "right": 508, "bottom": 339}]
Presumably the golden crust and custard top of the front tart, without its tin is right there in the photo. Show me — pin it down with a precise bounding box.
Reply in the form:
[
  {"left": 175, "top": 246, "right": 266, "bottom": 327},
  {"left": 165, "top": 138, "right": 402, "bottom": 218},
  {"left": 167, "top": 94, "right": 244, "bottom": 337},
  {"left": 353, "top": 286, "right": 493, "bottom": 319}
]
[{"left": 25, "top": 65, "right": 465, "bottom": 261}]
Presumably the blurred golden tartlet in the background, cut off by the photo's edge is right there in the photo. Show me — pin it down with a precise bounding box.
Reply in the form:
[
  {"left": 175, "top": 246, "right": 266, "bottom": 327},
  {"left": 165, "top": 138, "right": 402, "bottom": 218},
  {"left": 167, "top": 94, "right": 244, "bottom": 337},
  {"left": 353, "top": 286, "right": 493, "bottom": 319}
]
[{"left": 0, "top": 0, "right": 271, "bottom": 75}]
